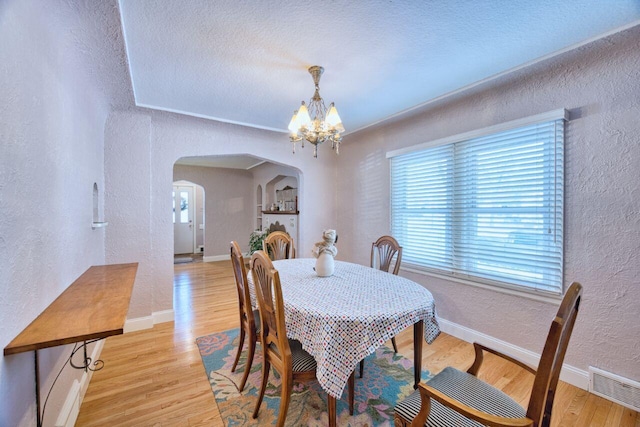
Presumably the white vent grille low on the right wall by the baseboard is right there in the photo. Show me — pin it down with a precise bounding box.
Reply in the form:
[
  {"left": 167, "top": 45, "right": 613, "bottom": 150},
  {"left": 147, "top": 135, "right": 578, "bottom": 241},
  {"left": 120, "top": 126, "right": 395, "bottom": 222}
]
[{"left": 589, "top": 366, "right": 640, "bottom": 411}]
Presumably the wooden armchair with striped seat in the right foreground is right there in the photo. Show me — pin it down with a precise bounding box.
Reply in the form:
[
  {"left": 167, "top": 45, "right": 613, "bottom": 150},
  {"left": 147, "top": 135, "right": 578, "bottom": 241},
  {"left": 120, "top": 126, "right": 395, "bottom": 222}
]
[{"left": 395, "top": 282, "right": 582, "bottom": 427}]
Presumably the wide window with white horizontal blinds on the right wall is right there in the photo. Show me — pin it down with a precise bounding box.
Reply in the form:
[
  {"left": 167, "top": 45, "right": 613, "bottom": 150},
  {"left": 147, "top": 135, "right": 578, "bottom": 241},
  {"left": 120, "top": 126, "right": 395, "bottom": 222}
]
[{"left": 387, "top": 110, "right": 566, "bottom": 294}]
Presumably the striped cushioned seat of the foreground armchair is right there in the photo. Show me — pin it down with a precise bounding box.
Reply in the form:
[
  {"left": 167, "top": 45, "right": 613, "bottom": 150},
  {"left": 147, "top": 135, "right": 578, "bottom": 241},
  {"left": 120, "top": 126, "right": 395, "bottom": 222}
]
[{"left": 395, "top": 367, "right": 526, "bottom": 427}]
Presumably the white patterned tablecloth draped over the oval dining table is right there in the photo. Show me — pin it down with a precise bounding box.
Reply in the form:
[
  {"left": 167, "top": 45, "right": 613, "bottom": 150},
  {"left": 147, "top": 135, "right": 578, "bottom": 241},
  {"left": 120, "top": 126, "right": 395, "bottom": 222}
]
[{"left": 247, "top": 258, "right": 440, "bottom": 398}]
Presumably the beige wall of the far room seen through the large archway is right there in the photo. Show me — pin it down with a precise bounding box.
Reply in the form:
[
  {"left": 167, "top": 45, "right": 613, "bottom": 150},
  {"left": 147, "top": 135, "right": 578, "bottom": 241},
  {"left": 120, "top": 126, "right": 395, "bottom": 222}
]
[{"left": 173, "top": 165, "right": 255, "bottom": 256}]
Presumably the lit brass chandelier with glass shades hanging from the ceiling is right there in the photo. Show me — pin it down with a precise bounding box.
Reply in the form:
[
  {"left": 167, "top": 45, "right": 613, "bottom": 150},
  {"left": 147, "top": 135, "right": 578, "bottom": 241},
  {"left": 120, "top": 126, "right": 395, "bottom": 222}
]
[{"left": 289, "top": 65, "right": 344, "bottom": 157}]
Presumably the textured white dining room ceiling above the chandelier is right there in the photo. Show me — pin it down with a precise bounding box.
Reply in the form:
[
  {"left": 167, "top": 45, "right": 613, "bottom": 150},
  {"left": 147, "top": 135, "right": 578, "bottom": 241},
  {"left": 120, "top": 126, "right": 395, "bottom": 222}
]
[{"left": 120, "top": 0, "right": 640, "bottom": 134}]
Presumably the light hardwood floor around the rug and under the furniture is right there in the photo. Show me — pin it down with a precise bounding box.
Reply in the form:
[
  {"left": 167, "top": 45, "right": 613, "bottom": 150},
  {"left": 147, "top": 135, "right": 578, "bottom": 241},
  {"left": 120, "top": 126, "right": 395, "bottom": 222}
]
[{"left": 76, "top": 261, "right": 640, "bottom": 427}]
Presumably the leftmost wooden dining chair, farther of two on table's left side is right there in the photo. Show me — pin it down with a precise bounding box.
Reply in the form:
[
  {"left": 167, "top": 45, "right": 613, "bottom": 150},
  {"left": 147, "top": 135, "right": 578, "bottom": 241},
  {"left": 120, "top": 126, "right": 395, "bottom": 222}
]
[{"left": 231, "top": 241, "right": 260, "bottom": 391}]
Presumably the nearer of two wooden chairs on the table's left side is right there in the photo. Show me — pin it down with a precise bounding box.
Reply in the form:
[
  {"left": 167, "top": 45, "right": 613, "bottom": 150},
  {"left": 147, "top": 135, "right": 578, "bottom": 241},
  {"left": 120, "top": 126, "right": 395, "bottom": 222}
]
[{"left": 251, "top": 251, "right": 354, "bottom": 427}]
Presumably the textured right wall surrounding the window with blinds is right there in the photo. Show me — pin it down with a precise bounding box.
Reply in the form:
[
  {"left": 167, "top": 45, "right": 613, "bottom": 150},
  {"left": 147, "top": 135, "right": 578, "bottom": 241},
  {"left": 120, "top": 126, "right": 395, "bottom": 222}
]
[{"left": 338, "top": 27, "right": 640, "bottom": 381}]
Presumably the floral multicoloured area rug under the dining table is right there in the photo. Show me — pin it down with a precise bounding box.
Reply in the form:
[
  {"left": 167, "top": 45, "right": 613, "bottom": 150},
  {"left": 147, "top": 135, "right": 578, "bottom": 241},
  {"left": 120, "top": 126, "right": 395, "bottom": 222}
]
[{"left": 196, "top": 329, "right": 430, "bottom": 427}]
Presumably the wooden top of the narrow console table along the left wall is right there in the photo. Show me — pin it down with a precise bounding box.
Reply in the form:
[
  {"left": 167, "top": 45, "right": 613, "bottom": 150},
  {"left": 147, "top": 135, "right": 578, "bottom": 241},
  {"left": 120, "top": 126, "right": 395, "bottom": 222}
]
[{"left": 4, "top": 263, "right": 138, "bottom": 356}]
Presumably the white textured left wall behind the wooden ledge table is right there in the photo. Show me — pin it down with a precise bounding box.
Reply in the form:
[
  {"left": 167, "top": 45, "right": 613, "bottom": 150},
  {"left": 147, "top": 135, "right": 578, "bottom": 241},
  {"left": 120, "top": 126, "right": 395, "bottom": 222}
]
[{"left": 0, "top": 0, "right": 109, "bottom": 426}]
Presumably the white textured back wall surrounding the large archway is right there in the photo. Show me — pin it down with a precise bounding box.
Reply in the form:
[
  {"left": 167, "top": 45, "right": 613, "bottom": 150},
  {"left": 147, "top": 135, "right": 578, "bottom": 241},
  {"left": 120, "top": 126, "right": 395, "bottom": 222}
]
[{"left": 105, "top": 109, "right": 337, "bottom": 319}]
